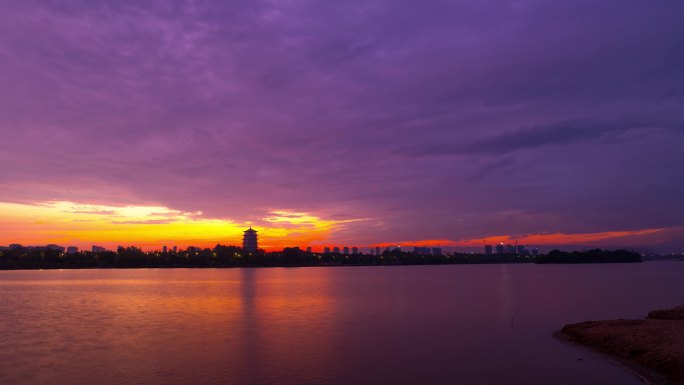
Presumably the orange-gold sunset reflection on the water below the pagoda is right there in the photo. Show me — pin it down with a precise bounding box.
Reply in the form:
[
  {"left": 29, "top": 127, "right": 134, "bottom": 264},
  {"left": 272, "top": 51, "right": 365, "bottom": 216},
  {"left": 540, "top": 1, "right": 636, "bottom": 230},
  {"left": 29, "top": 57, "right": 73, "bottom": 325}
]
[{"left": 0, "top": 269, "right": 334, "bottom": 383}]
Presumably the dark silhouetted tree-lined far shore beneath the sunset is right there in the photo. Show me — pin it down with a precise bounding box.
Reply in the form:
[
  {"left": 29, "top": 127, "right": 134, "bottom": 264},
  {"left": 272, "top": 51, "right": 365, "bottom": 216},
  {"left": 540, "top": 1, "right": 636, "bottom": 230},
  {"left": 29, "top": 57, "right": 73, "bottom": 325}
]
[{"left": 0, "top": 245, "right": 642, "bottom": 270}]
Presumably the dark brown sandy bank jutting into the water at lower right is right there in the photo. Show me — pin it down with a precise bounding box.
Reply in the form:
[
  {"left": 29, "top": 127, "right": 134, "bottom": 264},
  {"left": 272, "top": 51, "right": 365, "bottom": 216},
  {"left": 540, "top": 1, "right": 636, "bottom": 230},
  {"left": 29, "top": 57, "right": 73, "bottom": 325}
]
[{"left": 555, "top": 306, "right": 684, "bottom": 385}]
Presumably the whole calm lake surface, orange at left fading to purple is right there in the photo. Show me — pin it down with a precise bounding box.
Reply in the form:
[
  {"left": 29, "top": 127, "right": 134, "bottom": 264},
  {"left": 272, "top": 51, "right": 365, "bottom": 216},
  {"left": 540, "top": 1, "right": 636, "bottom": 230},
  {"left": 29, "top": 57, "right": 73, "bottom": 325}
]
[{"left": 0, "top": 262, "right": 684, "bottom": 385}]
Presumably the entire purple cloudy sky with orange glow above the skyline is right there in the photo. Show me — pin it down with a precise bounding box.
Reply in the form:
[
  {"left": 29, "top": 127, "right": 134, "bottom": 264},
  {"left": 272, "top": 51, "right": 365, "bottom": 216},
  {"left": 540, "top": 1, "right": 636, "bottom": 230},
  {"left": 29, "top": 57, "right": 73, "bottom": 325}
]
[{"left": 0, "top": 0, "right": 684, "bottom": 252}]
